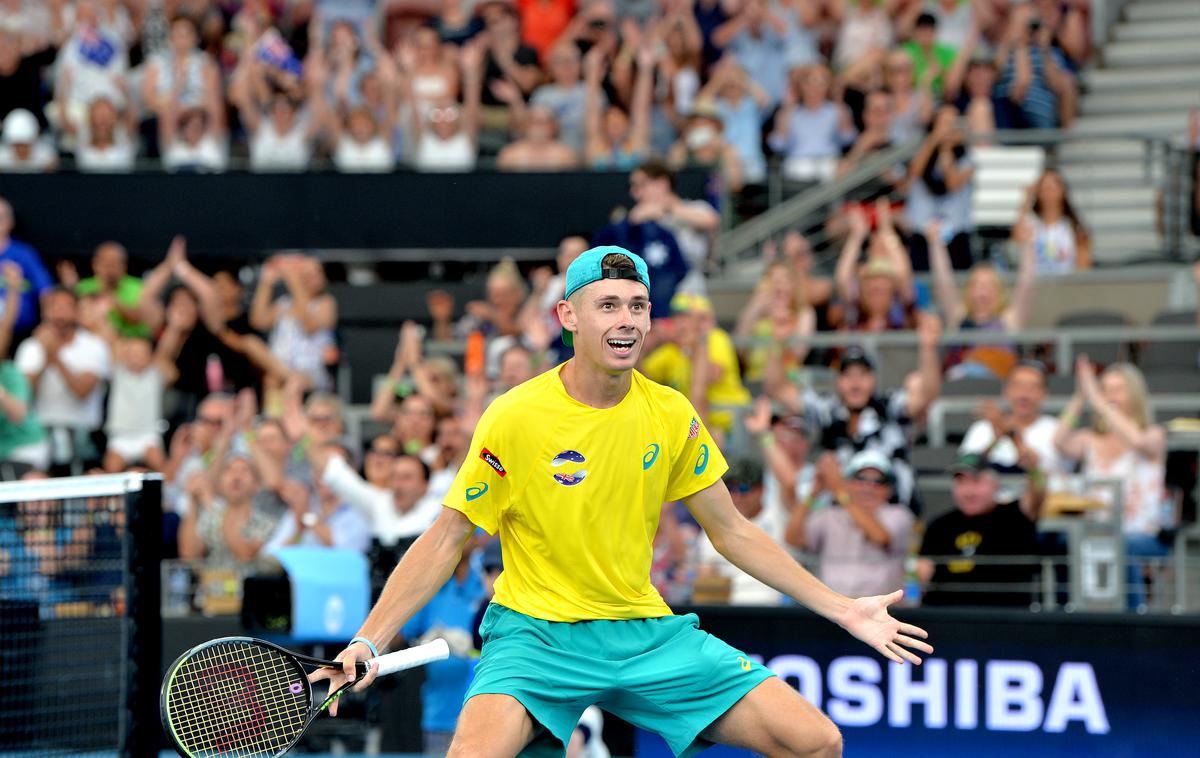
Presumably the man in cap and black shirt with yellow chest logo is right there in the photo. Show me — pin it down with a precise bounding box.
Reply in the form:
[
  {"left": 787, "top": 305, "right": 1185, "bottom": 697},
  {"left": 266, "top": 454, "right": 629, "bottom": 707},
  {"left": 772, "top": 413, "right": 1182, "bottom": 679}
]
[{"left": 917, "top": 453, "right": 1045, "bottom": 607}]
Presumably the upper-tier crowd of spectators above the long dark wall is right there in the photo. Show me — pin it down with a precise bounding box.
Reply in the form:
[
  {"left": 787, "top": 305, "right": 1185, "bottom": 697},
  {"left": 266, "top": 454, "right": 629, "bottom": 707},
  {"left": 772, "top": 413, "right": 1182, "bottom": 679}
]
[{"left": 0, "top": 0, "right": 1090, "bottom": 192}]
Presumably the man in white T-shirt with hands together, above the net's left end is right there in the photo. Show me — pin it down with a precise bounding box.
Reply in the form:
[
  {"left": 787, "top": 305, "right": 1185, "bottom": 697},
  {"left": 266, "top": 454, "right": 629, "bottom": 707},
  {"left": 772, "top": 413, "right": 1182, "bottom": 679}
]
[{"left": 16, "top": 288, "right": 112, "bottom": 463}]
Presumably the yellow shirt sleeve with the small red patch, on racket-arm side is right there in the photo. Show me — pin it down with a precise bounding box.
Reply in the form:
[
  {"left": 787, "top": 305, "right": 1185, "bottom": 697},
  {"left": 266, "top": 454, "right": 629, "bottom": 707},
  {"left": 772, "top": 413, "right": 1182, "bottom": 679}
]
[{"left": 443, "top": 398, "right": 517, "bottom": 534}]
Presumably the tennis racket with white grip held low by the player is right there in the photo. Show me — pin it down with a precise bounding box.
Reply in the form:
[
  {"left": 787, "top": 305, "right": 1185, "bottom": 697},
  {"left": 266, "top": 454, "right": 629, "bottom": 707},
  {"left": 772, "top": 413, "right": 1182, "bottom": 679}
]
[{"left": 158, "top": 637, "right": 450, "bottom": 758}]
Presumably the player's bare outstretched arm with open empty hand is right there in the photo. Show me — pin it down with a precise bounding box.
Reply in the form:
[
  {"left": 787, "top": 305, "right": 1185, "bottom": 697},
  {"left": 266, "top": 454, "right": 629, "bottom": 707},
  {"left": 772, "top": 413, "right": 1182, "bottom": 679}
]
[{"left": 686, "top": 481, "right": 934, "bottom": 664}]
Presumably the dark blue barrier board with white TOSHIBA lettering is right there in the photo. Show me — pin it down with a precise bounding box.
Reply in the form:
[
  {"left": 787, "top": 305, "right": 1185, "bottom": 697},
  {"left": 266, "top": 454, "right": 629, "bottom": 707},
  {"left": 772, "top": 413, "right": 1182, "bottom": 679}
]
[{"left": 637, "top": 608, "right": 1200, "bottom": 758}]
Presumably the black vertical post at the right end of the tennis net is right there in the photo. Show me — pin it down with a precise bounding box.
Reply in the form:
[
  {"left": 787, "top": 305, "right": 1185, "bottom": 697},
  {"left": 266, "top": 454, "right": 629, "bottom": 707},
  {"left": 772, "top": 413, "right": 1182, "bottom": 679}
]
[{"left": 120, "top": 475, "right": 162, "bottom": 758}]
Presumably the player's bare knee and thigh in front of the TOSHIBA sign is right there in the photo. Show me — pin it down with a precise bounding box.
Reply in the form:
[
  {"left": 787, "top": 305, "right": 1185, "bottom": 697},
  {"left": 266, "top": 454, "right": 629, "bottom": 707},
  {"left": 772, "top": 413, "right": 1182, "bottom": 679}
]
[{"left": 703, "top": 676, "right": 841, "bottom": 758}]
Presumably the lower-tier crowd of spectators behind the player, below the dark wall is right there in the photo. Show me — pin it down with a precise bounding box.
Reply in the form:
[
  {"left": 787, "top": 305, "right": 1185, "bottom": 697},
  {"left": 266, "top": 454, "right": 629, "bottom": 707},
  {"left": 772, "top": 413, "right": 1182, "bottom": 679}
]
[{"left": 0, "top": 164, "right": 1200, "bottom": 628}]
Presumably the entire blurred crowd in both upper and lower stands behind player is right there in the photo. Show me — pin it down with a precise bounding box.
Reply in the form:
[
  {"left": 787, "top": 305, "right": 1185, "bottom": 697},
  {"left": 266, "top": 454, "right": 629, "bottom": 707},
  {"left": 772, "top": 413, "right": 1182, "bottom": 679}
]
[{"left": 0, "top": 0, "right": 1200, "bottom": 745}]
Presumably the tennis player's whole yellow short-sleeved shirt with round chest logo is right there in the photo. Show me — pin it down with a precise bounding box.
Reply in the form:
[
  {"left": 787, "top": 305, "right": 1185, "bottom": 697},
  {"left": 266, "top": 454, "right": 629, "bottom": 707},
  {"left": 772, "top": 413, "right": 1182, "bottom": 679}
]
[{"left": 445, "top": 366, "right": 728, "bottom": 621}]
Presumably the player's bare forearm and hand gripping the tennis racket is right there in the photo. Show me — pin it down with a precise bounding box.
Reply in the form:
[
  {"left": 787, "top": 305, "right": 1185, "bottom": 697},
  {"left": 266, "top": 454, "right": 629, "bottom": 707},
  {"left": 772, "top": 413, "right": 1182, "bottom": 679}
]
[{"left": 308, "top": 507, "right": 475, "bottom": 716}]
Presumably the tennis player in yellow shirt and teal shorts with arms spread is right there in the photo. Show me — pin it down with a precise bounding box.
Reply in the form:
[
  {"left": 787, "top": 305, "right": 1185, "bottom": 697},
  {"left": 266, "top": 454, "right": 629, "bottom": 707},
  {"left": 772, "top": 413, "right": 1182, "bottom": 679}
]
[{"left": 313, "top": 247, "right": 932, "bottom": 758}]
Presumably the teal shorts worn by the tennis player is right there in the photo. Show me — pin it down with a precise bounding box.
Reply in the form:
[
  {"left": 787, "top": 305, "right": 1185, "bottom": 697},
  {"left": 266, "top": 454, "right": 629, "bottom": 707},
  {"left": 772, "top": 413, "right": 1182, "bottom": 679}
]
[{"left": 466, "top": 603, "right": 774, "bottom": 756}]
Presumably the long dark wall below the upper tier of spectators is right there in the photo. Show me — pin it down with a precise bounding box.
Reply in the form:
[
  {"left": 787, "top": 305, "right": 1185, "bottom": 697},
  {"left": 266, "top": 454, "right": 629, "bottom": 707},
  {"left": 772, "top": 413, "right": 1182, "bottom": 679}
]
[{"left": 0, "top": 172, "right": 704, "bottom": 258}]
